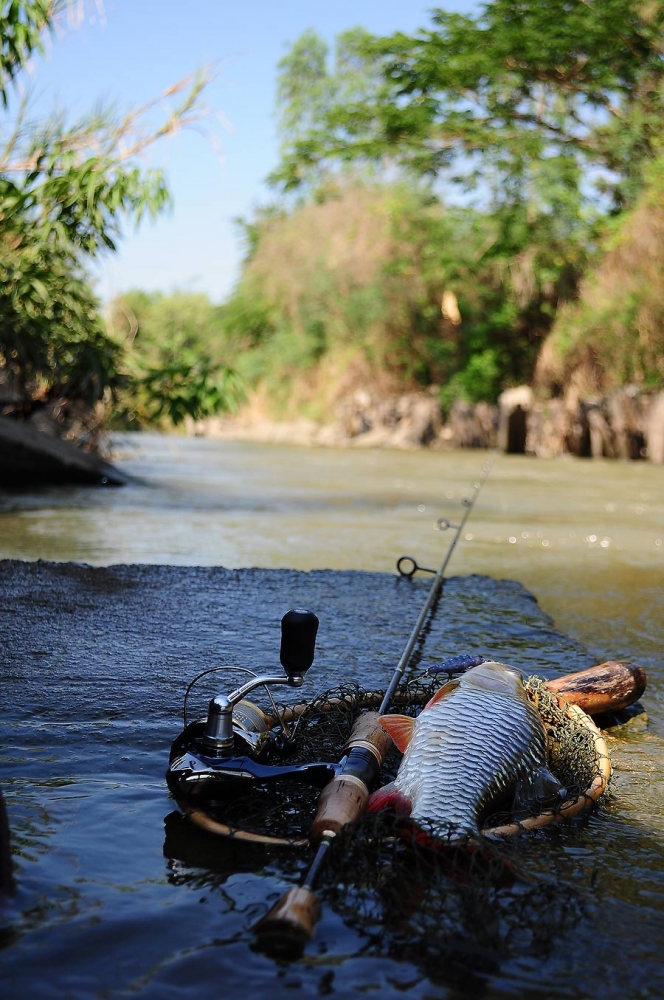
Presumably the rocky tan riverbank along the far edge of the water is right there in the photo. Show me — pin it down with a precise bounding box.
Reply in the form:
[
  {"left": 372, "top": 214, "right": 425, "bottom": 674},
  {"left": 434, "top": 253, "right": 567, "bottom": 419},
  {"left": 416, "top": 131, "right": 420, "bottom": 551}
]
[{"left": 186, "top": 386, "right": 664, "bottom": 464}]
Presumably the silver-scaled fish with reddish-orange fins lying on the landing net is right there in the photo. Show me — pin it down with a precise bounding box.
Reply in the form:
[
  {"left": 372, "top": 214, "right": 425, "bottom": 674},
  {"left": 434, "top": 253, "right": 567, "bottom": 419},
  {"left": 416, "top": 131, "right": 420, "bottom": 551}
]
[{"left": 367, "top": 660, "right": 562, "bottom": 840}]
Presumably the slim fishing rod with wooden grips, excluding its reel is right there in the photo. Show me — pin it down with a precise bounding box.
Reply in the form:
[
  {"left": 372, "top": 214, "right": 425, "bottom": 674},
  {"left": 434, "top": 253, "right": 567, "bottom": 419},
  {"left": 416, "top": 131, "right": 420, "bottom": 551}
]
[{"left": 254, "top": 460, "right": 493, "bottom": 957}]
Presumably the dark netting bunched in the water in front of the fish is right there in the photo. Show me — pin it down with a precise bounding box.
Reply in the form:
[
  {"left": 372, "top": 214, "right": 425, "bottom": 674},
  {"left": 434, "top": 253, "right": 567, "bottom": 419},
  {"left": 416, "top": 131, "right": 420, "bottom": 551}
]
[{"left": 318, "top": 814, "right": 586, "bottom": 980}]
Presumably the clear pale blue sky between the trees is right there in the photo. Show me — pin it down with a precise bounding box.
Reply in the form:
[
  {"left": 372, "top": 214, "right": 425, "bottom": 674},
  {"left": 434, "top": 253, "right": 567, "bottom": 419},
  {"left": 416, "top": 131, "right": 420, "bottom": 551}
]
[{"left": 20, "top": 0, "right": 473, "bottom": 302}]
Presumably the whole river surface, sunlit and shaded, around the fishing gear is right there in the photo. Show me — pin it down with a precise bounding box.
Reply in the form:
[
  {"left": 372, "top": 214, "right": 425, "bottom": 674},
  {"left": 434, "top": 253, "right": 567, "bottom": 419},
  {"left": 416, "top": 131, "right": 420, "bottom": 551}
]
[{"left": 0, "top": 435, "right": 664, "bottom": 997}]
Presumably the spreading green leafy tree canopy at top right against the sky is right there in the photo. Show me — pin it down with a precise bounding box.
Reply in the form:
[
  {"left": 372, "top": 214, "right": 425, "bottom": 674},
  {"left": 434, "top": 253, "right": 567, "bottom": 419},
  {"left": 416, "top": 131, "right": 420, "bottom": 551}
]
[{"left": 274, "top": 0, "right": 664, "bottom": 204}]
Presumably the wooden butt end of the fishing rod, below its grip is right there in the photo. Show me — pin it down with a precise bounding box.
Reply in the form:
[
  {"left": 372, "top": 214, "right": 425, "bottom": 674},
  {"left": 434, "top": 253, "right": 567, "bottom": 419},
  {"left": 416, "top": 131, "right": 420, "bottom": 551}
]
[{"left": 254, "top": 886, "right": 320, "bottom": 959}]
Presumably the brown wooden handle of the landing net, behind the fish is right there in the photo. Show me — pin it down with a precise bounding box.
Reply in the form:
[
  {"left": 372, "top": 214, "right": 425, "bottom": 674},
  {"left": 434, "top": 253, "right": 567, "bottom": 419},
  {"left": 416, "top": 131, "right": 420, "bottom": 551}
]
[{"left": 545, "top": 660, "right": 646, "bottom": 715}]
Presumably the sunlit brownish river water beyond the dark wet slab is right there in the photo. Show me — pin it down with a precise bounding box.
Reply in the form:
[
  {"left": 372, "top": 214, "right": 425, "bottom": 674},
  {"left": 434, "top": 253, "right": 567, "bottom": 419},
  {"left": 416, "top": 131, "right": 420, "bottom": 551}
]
[{"left": 0, "top": 434, "right": 664, "bottom": 657}]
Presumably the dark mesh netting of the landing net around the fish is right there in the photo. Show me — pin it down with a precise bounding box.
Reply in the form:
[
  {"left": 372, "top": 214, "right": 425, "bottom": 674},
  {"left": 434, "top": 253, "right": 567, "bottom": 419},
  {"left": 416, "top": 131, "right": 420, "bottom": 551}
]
[{"left": 176, "top": 678, "right": 603, "bottom": 972}]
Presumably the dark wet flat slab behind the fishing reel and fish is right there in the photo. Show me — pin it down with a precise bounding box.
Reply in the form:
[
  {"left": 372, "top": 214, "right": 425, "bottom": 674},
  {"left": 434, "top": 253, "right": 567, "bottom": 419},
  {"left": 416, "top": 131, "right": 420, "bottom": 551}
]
[{"left": 0, "top": 560, "right": 591, "bottom": 738}]
